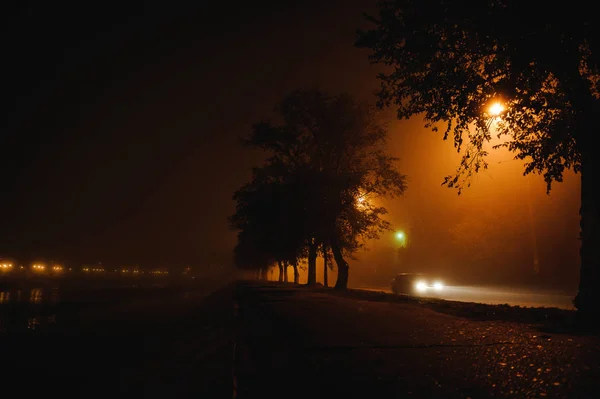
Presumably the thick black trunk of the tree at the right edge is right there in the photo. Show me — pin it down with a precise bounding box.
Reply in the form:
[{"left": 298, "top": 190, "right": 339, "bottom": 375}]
[{"left": 574, "top": 148, "right": 600, "bottom": 323}]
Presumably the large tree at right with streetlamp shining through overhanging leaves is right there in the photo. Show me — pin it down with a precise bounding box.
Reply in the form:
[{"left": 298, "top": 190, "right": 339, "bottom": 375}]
[{"left": 356, "top": 0, "right": 600, "bottom": 315}]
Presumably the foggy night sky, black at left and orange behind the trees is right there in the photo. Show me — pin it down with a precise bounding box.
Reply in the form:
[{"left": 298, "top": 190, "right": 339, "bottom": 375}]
[{"left": 0, "top": 0, "right": 579, "bottom": 285}]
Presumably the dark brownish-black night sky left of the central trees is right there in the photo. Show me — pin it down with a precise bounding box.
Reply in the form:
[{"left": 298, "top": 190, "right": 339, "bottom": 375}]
[{"left": 0, "top": 1, "right": 375, "bottom": 263}]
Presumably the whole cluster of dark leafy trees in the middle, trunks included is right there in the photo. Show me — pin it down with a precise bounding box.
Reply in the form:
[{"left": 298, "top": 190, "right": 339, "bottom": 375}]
[{"left": 230, "top": 90, "right": 406, "bottom": 289}]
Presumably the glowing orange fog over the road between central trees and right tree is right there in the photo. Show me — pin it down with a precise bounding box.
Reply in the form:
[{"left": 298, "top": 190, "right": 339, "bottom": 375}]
[{"left": 270, "top": 119, "right": 580, "bottom": 294}]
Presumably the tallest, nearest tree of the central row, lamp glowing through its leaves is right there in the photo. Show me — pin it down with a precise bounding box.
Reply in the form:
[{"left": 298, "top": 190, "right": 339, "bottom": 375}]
[{"left": 234, "top": 90, "right": 406, "bottom": 289}]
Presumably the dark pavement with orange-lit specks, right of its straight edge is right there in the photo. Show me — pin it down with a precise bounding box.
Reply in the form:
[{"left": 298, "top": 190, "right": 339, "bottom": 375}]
[{"left": 235, "top": 283, "right": 600, "bottom": 399}]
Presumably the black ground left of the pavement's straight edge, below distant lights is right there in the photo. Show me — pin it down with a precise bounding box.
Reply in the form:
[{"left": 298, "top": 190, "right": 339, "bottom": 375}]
[{"left": 0, "top": 281, "right": 234, "bottom": 398}]
